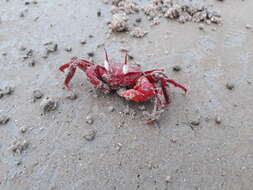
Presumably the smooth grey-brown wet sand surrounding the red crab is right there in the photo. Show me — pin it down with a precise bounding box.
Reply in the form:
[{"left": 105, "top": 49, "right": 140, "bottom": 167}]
[{"left": 0, "top": 0, "right": 253, "bottom": 190}]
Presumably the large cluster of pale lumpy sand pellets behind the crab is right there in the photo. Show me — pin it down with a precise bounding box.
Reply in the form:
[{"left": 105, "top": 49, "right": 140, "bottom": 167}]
[{"left": 107, "top": 0, "right": 222, "bottom": 38}]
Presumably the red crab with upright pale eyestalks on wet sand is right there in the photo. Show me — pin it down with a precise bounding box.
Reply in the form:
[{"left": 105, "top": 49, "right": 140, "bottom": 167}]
[{"left": 59, "top": 49, "right": 187, "bottom": 123}]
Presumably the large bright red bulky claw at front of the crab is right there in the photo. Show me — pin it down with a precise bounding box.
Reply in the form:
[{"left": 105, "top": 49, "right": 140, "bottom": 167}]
[{"left": 119, "top": 76, "right": 155, "bottom": 102}]
